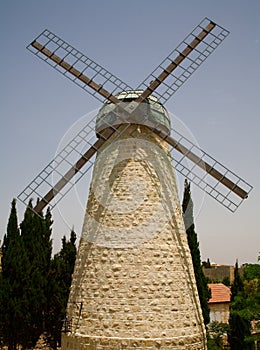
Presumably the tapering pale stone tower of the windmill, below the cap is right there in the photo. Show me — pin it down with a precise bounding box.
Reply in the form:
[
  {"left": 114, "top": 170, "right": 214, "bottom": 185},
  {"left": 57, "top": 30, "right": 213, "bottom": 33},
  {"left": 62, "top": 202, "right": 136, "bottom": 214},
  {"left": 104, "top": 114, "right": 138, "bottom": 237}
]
[{"left": 62, "top": 125, "right": 206, "bottom": 350}]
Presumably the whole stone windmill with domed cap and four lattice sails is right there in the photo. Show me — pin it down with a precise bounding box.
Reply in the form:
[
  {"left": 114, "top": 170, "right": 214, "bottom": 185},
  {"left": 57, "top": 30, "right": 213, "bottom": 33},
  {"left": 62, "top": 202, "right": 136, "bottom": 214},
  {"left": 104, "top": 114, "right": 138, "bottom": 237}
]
[{"left": 18, "top": 18, "right": 252, "bottom": 349}]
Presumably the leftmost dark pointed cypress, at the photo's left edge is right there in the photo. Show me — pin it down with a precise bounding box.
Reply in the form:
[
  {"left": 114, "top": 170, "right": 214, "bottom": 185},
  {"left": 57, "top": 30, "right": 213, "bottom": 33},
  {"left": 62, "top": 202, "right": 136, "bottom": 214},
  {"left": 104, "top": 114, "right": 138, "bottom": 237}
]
[{"left": 0, "top": 200, "right": 29, "bottom": 350}]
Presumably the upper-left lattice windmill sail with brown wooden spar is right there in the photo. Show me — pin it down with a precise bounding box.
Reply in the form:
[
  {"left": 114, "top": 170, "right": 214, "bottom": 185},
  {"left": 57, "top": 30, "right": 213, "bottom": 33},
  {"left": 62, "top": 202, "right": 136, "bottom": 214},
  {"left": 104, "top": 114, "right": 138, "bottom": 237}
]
[{"left": 27, "top": 29, "right": 131, "bottom": 103}]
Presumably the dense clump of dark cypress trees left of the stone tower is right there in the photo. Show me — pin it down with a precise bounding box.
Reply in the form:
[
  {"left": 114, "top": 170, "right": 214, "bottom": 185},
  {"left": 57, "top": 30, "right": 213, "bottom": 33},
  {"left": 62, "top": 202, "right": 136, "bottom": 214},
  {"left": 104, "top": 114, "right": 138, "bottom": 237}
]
[{"left": 0, "top": 200, "right": 76, "bottom": 350}]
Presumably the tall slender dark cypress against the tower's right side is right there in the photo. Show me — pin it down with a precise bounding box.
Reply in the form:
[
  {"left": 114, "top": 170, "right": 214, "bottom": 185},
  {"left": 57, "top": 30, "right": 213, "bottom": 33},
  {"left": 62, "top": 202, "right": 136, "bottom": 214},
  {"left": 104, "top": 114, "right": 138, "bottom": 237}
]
[{"left": 182, "top": 180, "right": 211, "bottom": 325}]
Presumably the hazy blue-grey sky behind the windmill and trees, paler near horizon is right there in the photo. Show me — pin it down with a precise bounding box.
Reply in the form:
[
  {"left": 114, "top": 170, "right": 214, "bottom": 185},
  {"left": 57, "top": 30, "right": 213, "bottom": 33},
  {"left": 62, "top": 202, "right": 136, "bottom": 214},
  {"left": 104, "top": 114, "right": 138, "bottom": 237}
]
[{"left": 0, "top": 0, "right": 260, "bottom": 264}]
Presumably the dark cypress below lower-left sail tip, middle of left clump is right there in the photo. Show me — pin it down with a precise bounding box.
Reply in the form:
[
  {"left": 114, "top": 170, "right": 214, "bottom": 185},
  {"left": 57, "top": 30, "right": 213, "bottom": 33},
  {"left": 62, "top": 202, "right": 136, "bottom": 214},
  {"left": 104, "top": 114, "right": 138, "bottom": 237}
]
[{"left": 20, "top": 201, "right": 52, "bottom": 347}]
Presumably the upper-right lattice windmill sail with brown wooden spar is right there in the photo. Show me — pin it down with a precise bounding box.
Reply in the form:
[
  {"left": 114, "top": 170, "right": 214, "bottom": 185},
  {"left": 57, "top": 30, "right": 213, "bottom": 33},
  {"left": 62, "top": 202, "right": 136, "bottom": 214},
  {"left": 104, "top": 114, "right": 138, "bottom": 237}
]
[{"left": 137, "top": 18, "right": 229, "bottom": 104}]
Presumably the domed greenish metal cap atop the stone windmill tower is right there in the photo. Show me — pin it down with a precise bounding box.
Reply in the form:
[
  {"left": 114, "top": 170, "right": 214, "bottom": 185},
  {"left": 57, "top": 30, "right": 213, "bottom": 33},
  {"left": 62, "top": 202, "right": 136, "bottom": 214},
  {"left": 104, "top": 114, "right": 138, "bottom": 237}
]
[{"left": 96, "top": 90, "right": 171, "bottom": 134}]
